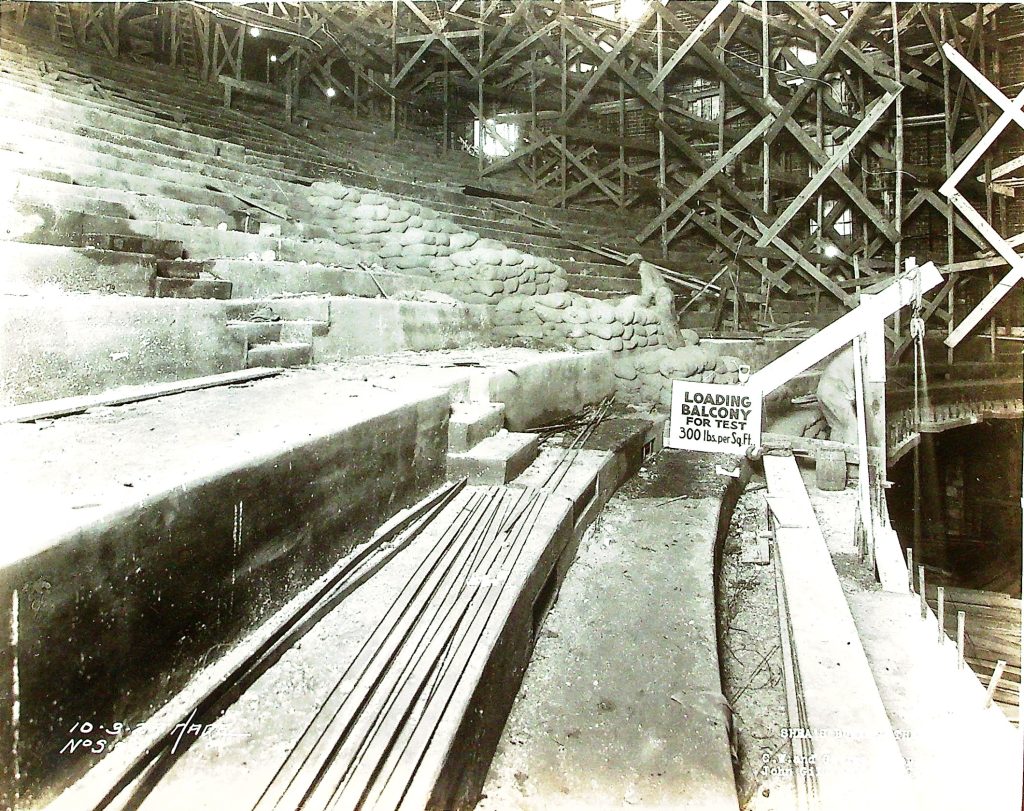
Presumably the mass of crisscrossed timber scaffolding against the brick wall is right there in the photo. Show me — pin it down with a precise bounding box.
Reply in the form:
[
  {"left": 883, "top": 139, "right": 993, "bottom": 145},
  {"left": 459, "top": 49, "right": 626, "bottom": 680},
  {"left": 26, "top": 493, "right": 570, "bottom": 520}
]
[{"left": 8, "top": 0, "right": 1024, "bottom": 344}]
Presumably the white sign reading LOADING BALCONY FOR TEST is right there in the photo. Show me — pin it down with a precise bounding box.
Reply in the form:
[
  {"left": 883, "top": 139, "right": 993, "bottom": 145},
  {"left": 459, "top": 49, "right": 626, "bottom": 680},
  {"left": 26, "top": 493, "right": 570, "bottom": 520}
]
[{"left": 666, "top": 380, "right": 761, "bottom": 456}]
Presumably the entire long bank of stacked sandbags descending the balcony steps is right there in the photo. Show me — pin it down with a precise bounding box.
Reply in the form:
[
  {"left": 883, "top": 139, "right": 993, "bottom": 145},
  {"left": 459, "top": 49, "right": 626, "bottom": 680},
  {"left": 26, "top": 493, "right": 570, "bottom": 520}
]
[{"left": 293, "top": 181, "right": 740, "bottom": 407}]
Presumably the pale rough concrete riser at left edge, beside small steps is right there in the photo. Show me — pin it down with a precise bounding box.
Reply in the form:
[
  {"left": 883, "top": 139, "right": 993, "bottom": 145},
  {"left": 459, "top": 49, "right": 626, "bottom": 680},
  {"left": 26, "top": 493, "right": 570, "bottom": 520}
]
[{"left": 0, "top": 295, "right": 245, "bottom": 406}]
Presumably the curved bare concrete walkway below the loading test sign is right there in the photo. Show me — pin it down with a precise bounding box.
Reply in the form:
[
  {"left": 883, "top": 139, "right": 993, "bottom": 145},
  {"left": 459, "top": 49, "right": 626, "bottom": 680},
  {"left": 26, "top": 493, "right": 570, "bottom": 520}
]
[{"left": 477, "top": 451, "right": 737, "bottom": 811}]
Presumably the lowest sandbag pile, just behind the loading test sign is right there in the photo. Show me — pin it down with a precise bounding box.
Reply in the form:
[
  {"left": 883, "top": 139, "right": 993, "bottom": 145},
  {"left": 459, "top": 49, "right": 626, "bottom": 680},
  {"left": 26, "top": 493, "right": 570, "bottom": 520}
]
[{"left": 614, "top": 339, "right": 741, "bottom": 408}]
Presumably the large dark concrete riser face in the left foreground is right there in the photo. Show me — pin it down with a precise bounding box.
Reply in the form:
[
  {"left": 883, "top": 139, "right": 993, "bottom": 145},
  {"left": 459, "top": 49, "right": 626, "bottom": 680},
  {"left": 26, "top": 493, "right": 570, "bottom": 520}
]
[{"left": 0, "top": 393, "right": 450, "bottom": 807}]
